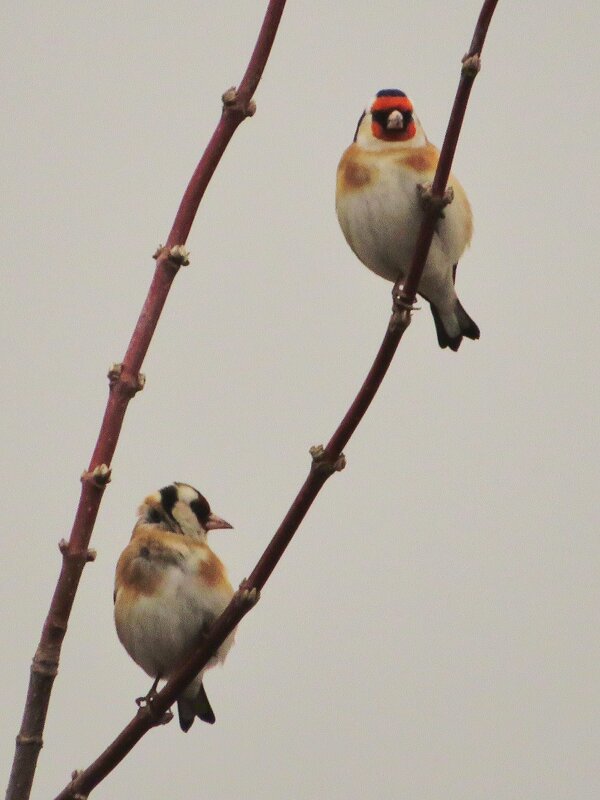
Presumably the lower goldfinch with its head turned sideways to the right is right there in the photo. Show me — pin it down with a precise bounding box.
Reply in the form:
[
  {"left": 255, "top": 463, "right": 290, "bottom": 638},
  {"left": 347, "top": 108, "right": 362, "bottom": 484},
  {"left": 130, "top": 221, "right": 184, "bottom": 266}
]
[{"left": 114, "top": 483, "right": 234, "bottom": 731}]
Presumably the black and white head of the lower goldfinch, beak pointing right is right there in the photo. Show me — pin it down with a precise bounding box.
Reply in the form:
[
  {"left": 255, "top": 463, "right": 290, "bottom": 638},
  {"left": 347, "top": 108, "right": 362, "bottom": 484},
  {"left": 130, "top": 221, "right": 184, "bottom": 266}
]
[{"left": 137, "top": 482, "right": 233, "bottom": 541}]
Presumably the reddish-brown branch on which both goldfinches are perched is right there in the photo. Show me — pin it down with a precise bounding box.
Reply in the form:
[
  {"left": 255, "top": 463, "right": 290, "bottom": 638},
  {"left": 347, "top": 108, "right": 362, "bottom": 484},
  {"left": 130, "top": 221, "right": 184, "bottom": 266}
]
[{"left": 56, "top": 0, "right": 498, "bottom": 800}]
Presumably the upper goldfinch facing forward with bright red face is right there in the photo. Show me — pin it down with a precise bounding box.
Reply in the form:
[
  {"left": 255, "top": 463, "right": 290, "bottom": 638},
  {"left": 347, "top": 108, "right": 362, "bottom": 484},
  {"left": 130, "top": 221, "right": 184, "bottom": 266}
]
[{"left": 336, "top": 89, "right": 479, "bottom": 350}]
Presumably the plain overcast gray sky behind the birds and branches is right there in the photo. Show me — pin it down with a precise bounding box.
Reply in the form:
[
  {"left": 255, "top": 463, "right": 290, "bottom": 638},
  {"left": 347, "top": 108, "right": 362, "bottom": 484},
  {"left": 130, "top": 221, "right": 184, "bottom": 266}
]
[{"left": 0, "top": 0, "right": 600, "bottom": 800}]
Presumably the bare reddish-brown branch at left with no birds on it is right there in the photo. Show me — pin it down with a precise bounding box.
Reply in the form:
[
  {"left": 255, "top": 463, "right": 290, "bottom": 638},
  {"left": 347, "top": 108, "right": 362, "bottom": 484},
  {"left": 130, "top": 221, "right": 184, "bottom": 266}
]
[{"left": 6, "top": 0, "right": 285, "bottom": 800}]
